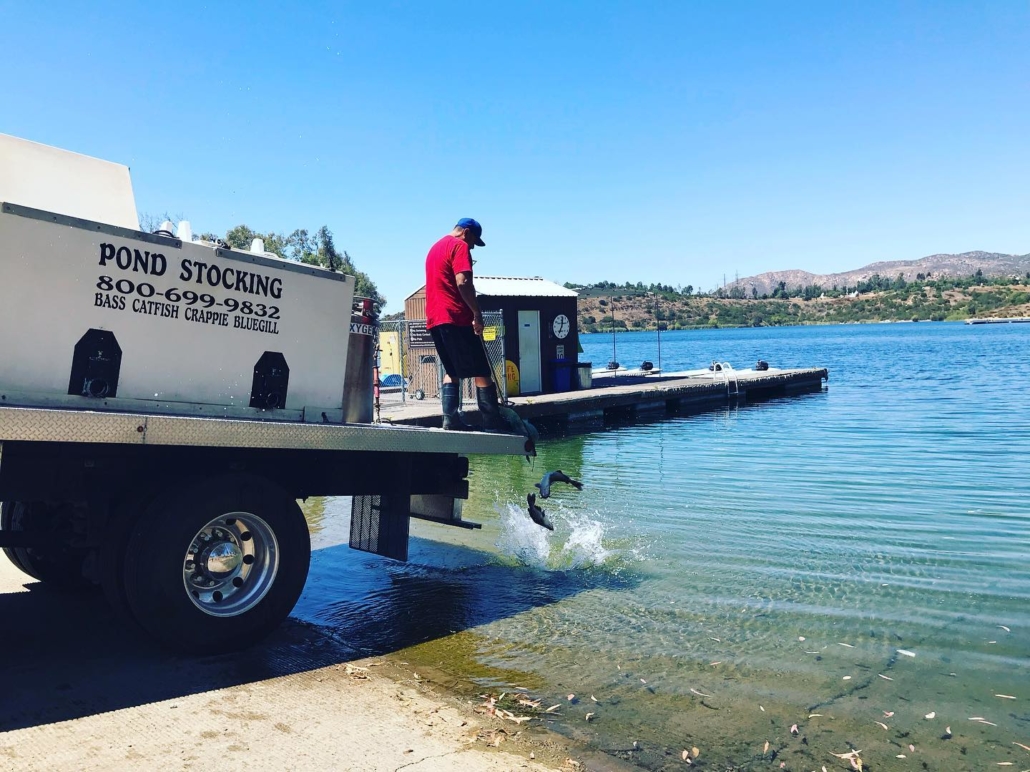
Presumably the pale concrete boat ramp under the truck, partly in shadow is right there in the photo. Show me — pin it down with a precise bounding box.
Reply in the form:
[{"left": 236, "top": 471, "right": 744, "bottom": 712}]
[{"left": 0, "top": 560, "right": 609, "bottom": 772}]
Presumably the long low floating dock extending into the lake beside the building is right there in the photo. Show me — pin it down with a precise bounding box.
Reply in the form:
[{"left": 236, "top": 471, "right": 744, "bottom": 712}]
[{"left": 380, "top": 367, "right": 829, "bottom": 428}]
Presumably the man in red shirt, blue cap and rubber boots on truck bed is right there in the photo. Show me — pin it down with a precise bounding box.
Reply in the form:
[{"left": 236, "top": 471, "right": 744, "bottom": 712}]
[{"left": 425, "top": 217, "right": 508, "bottom": 431}]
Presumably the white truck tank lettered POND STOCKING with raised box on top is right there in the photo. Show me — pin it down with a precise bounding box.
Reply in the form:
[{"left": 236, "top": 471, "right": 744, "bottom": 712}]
[{"left": 0, "top": 135, "right": 354, "bottom": 423}]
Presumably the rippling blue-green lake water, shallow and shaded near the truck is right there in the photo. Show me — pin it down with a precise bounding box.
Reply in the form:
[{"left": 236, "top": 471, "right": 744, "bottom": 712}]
[{"left": 296, "top": 323, "right": 1030, "bottom": 770}]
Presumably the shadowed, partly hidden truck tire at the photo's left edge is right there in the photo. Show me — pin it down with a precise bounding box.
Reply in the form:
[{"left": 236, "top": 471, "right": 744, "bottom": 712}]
[{"left": 0, "top": 501, "right": 93, "bottom": 590}]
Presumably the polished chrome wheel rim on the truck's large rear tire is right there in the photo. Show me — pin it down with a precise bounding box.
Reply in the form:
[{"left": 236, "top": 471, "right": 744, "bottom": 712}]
[{"left": 182, "top": 512, "right": 279, "bottom": 617}]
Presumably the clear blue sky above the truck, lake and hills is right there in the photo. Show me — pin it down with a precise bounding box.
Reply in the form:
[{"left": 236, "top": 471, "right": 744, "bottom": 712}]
[{"left": 0, "top": 0, "right": 1030, "bottom": 311}]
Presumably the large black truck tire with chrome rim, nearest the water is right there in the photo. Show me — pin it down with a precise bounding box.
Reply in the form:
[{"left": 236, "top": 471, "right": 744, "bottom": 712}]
[{"left": 125, "top": 475, "right": 311, "bottom": 654}]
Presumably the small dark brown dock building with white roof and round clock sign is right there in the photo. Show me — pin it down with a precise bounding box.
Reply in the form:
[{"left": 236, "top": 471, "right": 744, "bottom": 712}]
[{"left": 404, "top": 276, "right": 579, "bottom": 396}]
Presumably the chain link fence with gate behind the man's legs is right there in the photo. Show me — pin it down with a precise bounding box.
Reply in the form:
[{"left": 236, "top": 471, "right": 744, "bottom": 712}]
[{"left": 379, "top": 311, "right": 508, "bottom": 406}]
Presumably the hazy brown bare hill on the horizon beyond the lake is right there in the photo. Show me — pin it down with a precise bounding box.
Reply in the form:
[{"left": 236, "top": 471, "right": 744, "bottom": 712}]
[{"left": 726, "top": 252, "right": 1030, "bottom": 297}]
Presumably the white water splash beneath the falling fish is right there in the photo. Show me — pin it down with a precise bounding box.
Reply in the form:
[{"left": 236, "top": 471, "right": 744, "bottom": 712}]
[{"left": 494, "top": 501, "right": 615, "bottom": 571}]
